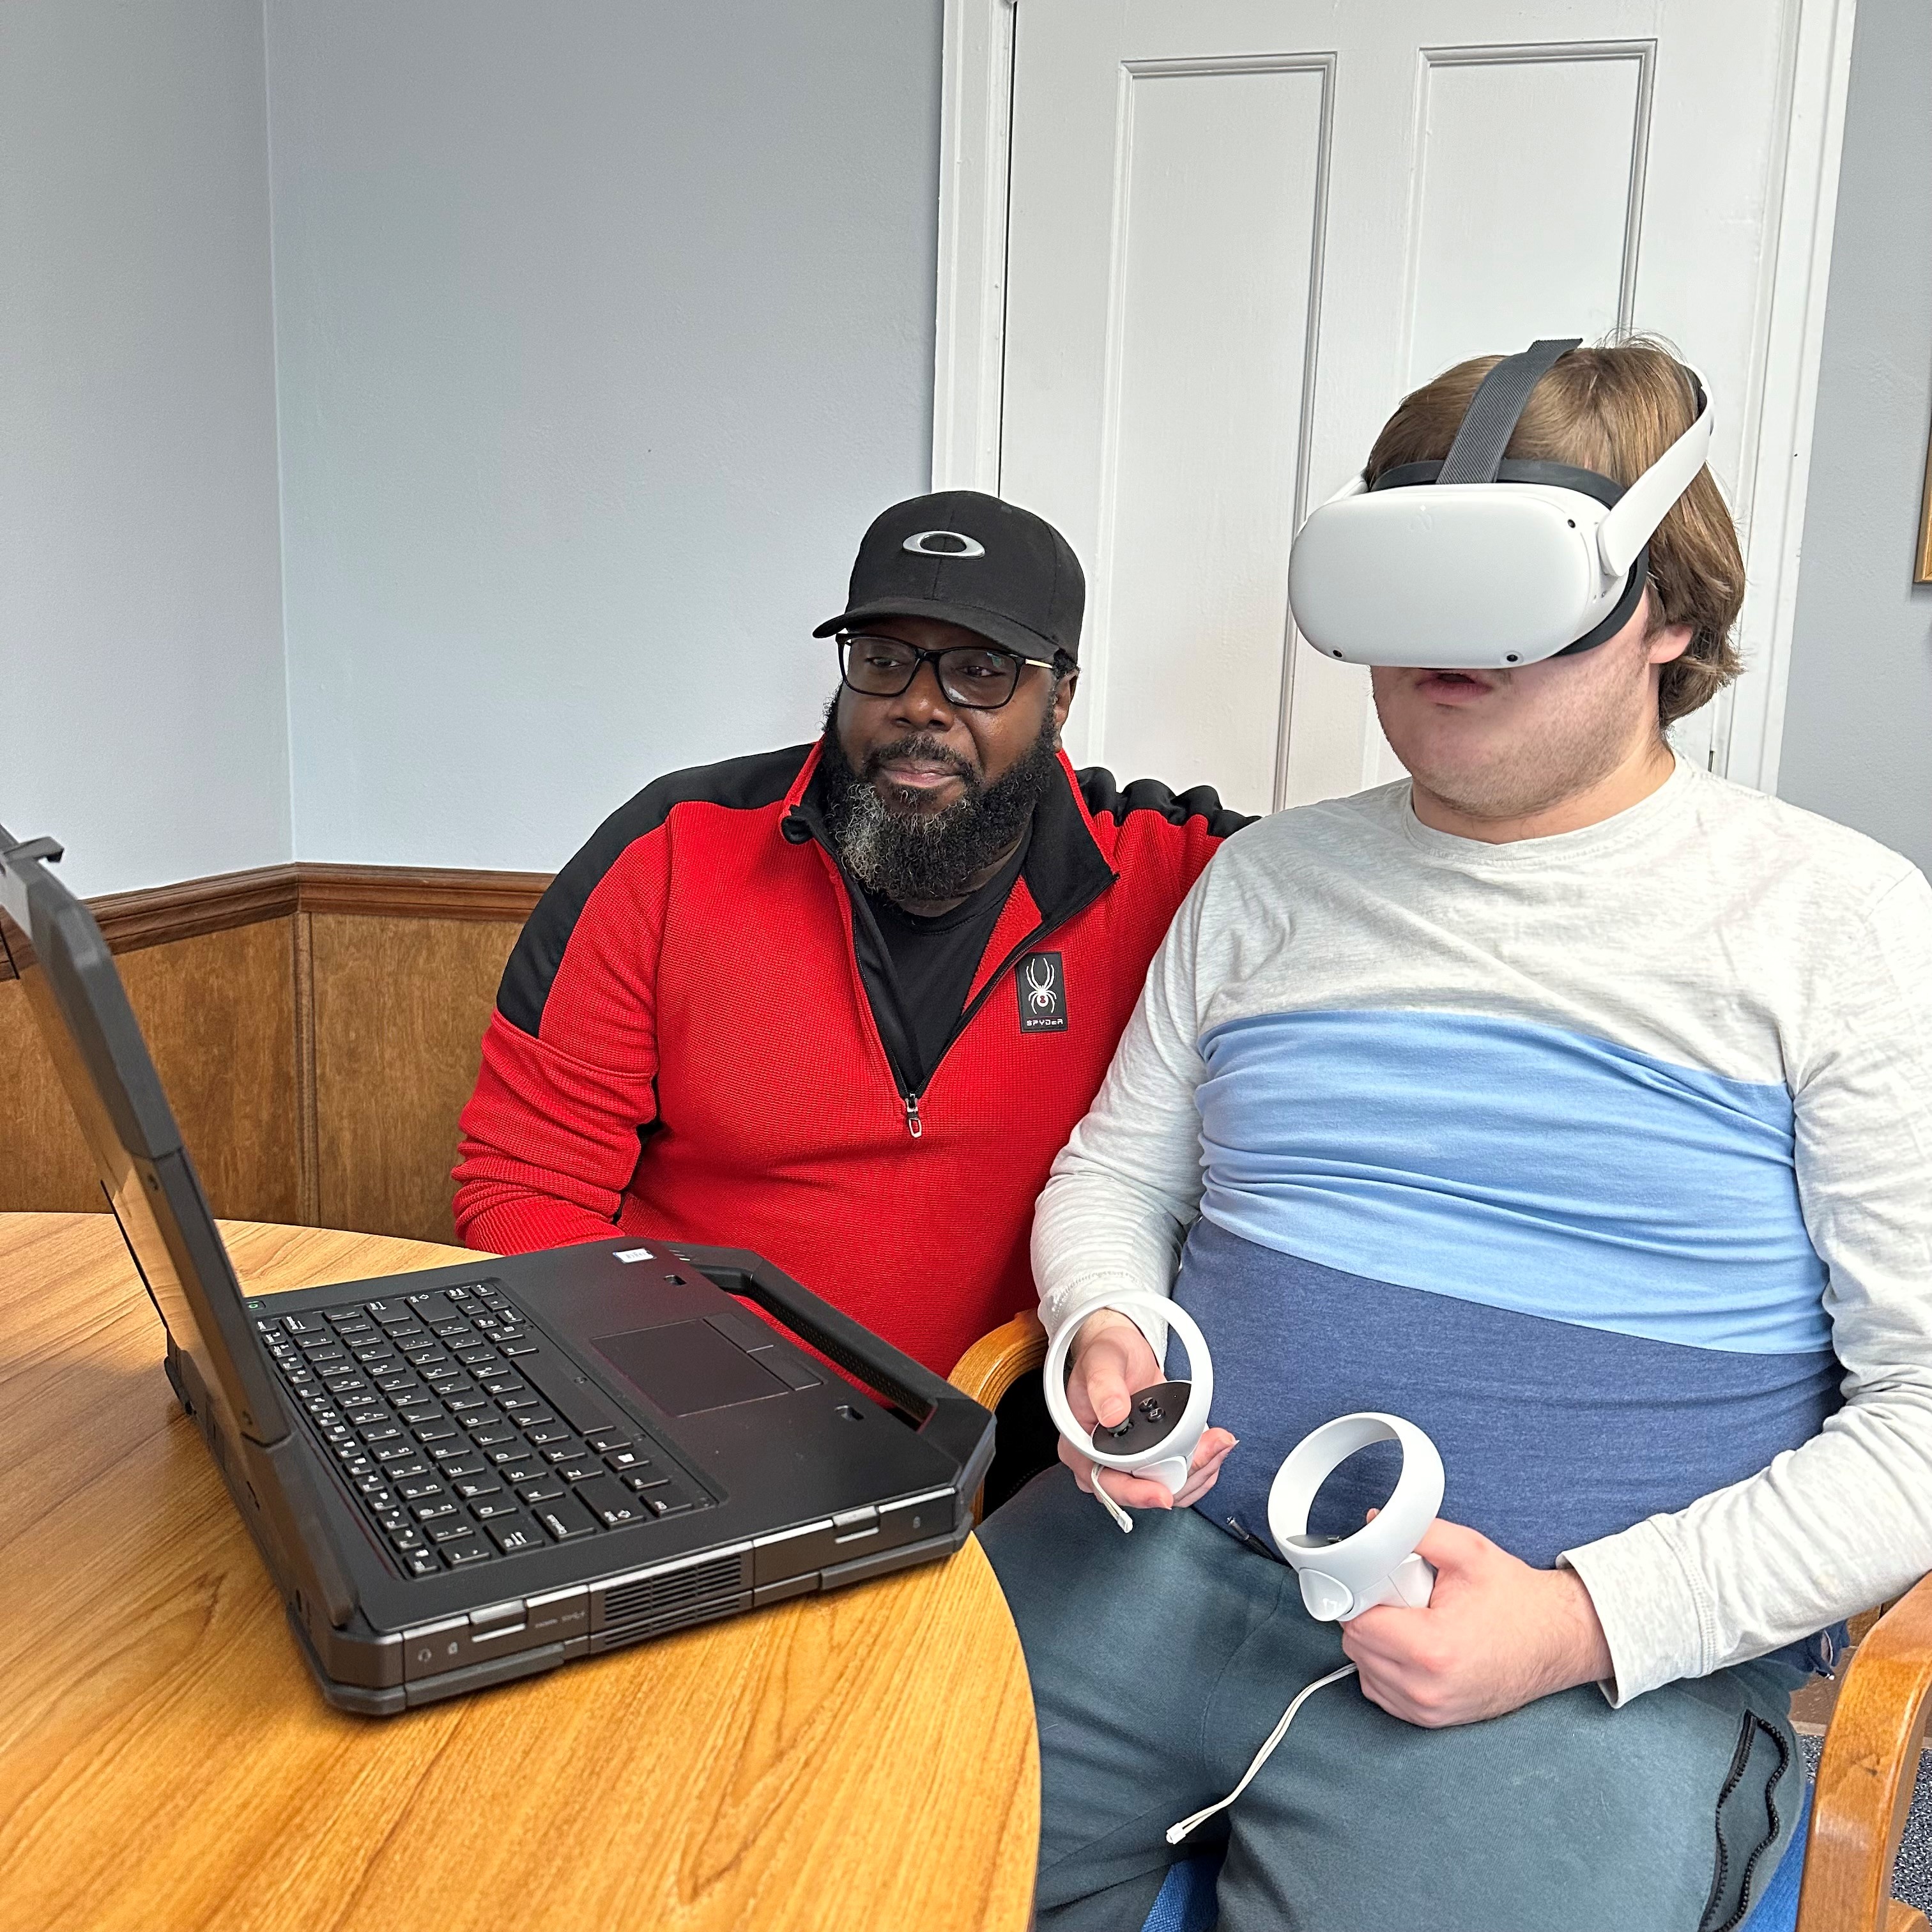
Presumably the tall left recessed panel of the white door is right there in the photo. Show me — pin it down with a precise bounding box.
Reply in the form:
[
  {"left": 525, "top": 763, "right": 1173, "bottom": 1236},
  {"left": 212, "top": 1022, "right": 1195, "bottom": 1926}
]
[{"left": 1084, "top": 64, "right": 1327, "bottom": 796}]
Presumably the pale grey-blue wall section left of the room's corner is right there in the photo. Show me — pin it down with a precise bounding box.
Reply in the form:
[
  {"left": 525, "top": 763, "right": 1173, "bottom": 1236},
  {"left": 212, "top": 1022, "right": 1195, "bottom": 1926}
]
[{"left": 0, "top": 0, "right": 290, "bottom": 893}]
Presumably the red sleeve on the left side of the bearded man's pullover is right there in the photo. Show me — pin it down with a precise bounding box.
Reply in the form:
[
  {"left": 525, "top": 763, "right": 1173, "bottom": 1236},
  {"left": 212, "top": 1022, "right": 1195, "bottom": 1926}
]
[{"left": 456, "top": 825, "right": 670, "bottom": 1254}]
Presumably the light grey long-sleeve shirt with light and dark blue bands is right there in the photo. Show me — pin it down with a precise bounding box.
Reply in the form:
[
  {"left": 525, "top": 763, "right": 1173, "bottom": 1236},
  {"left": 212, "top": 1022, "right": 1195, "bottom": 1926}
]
[{"left": 1034, "top": 763, "right": 1932, "bottom": 1702}]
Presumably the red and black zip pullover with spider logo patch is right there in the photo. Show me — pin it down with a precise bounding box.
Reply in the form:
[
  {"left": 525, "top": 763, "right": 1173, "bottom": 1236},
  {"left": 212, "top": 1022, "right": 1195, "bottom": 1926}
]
[{"left": 456, "top": 744, "right": 1248, "bottom": 1374}]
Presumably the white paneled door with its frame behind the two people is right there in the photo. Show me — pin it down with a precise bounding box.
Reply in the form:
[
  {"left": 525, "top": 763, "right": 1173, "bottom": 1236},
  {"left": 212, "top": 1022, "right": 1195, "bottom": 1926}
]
[{"left": 950, "top": 0, "right": 1849, "bottom": 811}]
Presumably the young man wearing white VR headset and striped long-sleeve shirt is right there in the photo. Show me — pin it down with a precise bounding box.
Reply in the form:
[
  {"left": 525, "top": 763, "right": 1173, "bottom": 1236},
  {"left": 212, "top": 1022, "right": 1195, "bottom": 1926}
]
[{"left": 981, "top": 342, "right": 1932, "bottom": 1932}]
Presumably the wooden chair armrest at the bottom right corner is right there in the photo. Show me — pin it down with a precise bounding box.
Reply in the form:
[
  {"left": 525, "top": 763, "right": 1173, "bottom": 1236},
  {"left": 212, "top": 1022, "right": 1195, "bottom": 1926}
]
[{"left": 1798, "top": 1577, "right": 1932, "bottom": 1932}]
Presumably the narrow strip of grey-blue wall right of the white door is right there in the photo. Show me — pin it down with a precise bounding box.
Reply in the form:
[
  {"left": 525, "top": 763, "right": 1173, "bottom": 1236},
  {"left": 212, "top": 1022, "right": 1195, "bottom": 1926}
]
[{"left": 1777, "top": 0, "right": 1932, "bottom": 871}]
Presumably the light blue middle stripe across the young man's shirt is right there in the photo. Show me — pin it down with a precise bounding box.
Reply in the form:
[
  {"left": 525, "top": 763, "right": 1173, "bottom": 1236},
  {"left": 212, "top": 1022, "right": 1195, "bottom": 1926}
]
[{"left": 1198, "top": 1011, "right": 1832, "bottom": 1354}]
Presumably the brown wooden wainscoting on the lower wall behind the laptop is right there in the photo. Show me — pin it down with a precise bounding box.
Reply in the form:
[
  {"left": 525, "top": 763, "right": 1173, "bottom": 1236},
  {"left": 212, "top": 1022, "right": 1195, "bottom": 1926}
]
[{"left": 0, "top": 864, "right": 549, "bottom": 1240}]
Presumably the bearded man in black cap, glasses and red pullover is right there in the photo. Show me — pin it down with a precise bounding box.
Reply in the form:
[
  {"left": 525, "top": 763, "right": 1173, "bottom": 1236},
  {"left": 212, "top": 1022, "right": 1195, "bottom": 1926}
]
[{"left": 456, "top": 491, "right": 1246, "bottom": 1374}]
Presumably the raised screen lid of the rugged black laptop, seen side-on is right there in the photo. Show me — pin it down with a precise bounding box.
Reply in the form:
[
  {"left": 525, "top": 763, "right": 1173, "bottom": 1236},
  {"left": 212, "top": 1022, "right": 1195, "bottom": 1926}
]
[{"left": 0, "top": 827, "right": 288, "bottom": 1443}]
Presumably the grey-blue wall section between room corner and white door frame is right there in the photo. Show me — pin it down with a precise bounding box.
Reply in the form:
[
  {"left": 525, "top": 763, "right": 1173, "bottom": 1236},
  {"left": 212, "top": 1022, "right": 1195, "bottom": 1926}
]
[{"left": 266, "top": 0, "right": 941, "bottom": 868}]
